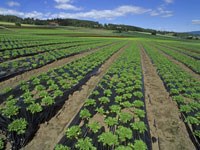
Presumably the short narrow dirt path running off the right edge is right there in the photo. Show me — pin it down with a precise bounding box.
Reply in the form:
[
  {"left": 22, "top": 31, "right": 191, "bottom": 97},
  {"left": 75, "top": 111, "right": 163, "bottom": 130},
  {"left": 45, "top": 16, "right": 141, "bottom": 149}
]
[{"left": 159, "top": 50, "right": 200, "bottom": 80}]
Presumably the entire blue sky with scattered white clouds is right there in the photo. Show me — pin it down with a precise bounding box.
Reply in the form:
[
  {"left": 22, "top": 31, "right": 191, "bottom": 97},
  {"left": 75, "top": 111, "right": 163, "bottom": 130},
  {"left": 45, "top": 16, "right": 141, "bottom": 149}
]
[{"left": 0, "top": 0, "right": 200, "bottom": 32}]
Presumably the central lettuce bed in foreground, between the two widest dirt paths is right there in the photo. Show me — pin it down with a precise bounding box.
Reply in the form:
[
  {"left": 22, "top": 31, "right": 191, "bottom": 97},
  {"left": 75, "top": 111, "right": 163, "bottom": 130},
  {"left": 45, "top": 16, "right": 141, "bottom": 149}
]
[{"left": 55, "top": 43, "right": 151, "bottom": 150}]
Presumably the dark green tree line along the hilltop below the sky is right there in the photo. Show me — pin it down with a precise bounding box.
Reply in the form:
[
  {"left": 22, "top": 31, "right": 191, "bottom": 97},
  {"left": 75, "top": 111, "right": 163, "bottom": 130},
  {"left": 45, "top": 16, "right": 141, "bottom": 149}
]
[{"left": 0, "top": 15, "right": 156, "bottom": 32}]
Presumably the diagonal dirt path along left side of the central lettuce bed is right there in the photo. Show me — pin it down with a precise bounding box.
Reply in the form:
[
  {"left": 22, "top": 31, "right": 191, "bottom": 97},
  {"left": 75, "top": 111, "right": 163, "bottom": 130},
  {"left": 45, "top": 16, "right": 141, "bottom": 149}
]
[{"left": 24, "top": 46, "right": 130, "bottom": 150}]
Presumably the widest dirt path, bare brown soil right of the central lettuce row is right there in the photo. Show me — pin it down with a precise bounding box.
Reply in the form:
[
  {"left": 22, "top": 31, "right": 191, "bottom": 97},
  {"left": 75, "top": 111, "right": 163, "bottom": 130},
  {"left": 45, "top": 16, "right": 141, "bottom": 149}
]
[{"left": 141, "top": 48, "right": 195, "bottom": 150}]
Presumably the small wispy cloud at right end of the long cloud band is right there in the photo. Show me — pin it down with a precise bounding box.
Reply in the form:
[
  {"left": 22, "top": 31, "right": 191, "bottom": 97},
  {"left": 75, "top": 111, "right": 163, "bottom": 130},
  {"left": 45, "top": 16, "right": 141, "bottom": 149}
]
[{"left": 150, "top": 7, "right": 173, "bottom": 18}]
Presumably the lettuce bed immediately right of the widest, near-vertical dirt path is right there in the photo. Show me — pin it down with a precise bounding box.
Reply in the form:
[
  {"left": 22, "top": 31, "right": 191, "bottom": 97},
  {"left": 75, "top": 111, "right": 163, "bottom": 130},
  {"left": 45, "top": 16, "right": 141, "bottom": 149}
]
[{"left": 143, "top": 43, "right": 200, "bottom": 147}]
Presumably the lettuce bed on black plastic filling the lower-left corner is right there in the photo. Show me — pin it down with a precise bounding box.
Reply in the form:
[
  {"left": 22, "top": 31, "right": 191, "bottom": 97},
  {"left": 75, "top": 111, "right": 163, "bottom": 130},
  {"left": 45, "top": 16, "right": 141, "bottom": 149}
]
[{"left": 0, "top": 42, "right": 126, "bottom": 149}]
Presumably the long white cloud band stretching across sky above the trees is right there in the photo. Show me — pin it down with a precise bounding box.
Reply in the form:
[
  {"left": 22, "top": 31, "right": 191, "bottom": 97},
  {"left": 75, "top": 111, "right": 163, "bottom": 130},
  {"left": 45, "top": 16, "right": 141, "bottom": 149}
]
[{"left": 0, "top": 5, "right": 173, "bottom": 20}]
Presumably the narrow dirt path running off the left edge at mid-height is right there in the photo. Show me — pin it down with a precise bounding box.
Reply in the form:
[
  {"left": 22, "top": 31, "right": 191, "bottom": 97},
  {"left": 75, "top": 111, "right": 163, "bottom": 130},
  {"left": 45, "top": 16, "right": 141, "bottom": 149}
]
[{"left": 0, "top": 44, "right": 112, "bottom": 91}]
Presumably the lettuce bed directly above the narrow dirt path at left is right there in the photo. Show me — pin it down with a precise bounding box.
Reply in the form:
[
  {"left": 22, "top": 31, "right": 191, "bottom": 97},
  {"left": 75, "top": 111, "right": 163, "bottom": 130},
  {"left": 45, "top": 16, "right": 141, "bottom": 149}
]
[{"left": 0, "top": 40, "right": 113, "bottom": 81}]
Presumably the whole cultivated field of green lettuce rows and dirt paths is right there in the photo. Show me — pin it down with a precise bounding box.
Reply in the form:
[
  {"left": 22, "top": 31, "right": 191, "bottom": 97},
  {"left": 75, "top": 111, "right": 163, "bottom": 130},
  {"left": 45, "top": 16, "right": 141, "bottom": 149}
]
[{"left": 0, "top": 27, "right": 200, "bottom": 150}]
